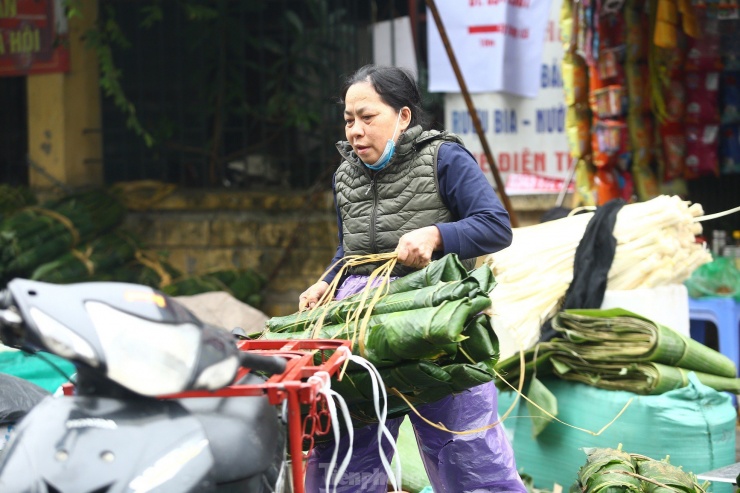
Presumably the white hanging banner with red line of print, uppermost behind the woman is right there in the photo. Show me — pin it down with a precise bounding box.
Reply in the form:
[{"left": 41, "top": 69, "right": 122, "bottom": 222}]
[{"left": 427, "top": 0, "right": 551, "bottom": 98}]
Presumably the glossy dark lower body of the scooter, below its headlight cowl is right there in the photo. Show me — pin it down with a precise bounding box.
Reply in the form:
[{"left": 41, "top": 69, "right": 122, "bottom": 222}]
[{"left": 0, "top": 378, "right": 285, "bottom": 493}]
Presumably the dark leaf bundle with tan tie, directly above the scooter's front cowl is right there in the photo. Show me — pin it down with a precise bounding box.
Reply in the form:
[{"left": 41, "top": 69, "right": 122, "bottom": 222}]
[{"left": 31, "top": 229, "right": 139, "bottom": 284}]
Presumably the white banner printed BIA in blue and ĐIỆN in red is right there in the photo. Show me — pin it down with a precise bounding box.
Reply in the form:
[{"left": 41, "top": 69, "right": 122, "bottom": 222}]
[{"left": 445, "top": 0, "right": 571, "bottom": 195}]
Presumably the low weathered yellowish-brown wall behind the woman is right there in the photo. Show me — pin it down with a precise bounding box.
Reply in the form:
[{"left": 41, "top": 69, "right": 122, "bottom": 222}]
[{"left": 121, "top": 186, "right": 555, "bottom": 316}]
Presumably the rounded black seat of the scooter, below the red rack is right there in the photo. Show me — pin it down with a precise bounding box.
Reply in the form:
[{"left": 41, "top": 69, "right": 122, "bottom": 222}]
[{"left": 179, "top": 374, "right": 285, "bottom": 483}]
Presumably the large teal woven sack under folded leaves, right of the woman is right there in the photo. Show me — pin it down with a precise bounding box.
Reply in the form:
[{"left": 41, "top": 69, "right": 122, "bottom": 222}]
[{"left": 498, "top": 375, "right": 737, "bottom": 493}]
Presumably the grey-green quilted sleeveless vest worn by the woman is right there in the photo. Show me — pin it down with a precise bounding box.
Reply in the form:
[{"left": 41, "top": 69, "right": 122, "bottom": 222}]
[{"left": 334, "top": 126, "right": 475, "bottom": 276}]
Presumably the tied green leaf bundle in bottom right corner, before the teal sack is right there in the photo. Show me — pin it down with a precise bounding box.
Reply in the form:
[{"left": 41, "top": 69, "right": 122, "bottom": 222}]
[{"left": 574, "top": 445, "right": 709, "bottom": 493}]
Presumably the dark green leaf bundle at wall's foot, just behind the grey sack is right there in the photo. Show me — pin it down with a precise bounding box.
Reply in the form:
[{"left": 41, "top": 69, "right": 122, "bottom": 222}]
[{"left": 161, "top": 269, "right": 266, "bottom": 307}]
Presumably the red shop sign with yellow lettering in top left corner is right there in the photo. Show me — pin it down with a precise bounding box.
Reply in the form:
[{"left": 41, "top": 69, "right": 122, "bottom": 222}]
[{"left": 0, "top": 0, "right": 69, "bottom": 77}]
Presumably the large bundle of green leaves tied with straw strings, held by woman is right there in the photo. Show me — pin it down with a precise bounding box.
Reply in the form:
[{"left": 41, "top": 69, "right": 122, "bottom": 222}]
[{"left": 261, "top": 255, "right": 498, "bottom": 425}]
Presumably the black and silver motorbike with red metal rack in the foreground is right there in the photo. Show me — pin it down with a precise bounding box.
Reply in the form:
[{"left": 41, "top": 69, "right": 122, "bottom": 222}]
[{"left": 0, "top": 279, "right": 350, "bottom": 493}]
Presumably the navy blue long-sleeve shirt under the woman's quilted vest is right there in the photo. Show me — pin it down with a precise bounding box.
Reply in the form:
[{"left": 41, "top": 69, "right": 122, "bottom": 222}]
[{"left": 324, "top": 142, "right": 512, "bottom": 283}]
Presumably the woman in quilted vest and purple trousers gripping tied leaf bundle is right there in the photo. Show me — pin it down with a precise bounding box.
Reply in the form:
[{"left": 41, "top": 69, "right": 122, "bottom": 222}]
[{"left": 299, "top": 65, "right": 526, "bottom": 493}]
